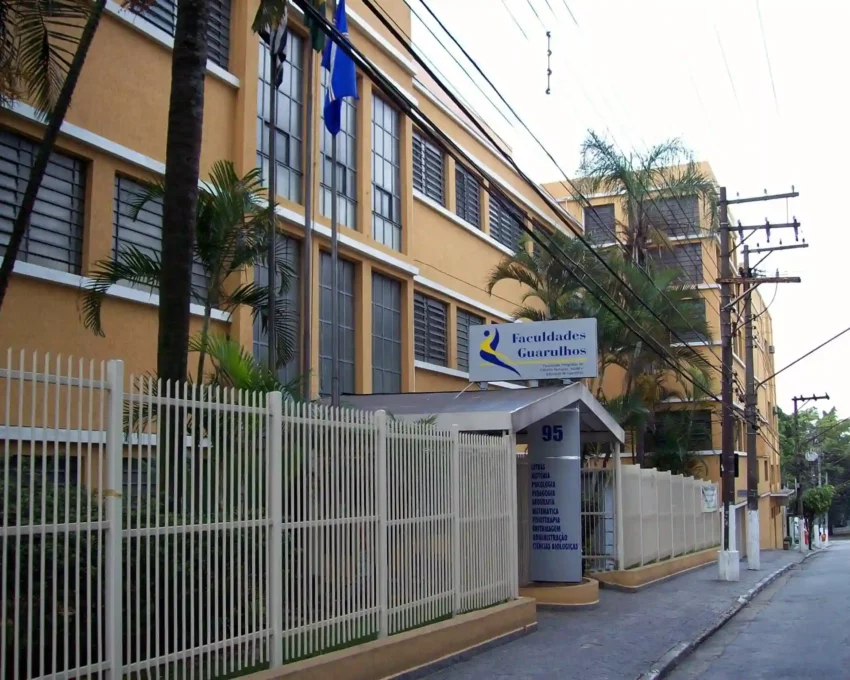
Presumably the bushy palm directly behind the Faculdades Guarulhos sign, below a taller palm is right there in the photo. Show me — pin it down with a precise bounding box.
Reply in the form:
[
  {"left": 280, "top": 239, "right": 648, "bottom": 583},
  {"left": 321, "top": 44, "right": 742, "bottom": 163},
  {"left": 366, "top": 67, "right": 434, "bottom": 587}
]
[{"left": 487, "top": 233, "right": 711, "bottom": 468}]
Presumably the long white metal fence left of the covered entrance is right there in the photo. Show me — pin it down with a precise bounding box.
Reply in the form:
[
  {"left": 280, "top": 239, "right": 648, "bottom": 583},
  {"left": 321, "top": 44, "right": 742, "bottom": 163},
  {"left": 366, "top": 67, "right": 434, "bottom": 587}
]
[{"left": 0, "top": 353, "right": 518, "bottom": 679}]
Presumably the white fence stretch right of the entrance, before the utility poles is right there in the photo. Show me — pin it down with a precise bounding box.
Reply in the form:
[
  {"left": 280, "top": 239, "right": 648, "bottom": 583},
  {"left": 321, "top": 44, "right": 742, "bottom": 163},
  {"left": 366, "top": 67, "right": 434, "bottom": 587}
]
[{"left": 620, "top": 465, "right": 721, "bottom": 569}]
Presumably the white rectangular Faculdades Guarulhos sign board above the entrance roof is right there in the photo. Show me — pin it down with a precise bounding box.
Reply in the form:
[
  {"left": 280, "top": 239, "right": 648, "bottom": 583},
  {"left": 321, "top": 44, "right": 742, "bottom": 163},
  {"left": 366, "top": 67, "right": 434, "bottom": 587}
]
[{"left": 469, "top": 319, "right": 598, "bottom": 382}]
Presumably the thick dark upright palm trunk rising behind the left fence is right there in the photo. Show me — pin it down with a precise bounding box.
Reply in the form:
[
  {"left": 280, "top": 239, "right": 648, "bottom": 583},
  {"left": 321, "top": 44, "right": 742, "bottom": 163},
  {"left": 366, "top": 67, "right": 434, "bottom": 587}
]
[{"left": 157, "top": 0, "right": 207, "bottom": 381}]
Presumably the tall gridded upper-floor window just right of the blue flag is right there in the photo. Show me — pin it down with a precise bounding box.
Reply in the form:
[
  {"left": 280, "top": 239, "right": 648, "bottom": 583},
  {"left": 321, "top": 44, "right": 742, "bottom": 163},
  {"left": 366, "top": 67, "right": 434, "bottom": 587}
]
[{"left": 372, "top": 96, "right": 401, "bottom": 250}]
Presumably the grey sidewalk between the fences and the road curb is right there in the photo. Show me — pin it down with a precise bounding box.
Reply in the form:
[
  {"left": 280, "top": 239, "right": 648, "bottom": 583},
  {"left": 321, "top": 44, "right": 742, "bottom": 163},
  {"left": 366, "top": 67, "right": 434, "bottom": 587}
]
[{"left": 428, "top": 550, "right": 802, "bottom": 680}]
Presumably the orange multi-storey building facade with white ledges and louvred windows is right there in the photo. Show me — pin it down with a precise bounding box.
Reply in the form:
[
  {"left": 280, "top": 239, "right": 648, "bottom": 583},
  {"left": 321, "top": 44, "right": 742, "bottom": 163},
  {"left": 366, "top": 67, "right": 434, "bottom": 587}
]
[{"left": 0, "top": 0, "right": 781, "bottom": 545}]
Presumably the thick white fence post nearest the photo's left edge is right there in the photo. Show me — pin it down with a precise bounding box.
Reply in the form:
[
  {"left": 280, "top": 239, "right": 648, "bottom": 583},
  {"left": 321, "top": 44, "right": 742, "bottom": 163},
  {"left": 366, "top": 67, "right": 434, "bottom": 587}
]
[{"left": 103, "top": 361, "right": 124, "bottom": 680}]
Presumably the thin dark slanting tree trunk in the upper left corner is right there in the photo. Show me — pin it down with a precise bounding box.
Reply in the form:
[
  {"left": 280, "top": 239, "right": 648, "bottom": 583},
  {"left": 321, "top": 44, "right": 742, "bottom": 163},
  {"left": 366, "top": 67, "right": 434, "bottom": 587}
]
[{"left": 0, "top": 0, "right": 106, "bottom": 310}]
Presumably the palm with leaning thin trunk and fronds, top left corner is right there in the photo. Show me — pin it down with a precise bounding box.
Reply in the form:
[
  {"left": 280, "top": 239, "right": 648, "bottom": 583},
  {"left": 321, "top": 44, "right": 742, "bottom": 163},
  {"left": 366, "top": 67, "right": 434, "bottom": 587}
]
[{"left": 0, "top": 0, "right": 112, "bottom": 309}]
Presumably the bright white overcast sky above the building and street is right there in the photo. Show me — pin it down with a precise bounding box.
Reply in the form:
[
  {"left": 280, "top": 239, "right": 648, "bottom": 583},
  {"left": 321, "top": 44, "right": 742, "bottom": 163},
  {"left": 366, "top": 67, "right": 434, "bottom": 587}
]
[{"left": 409, "top": 0, "right": 850, "bottom": 416}]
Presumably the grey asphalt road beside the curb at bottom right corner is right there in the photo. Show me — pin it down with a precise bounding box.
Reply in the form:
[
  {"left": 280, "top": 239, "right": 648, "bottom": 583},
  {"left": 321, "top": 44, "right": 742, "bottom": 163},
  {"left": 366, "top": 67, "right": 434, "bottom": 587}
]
[{"left": 668, "top": 540, "right": 850, "bottom": 680}]
